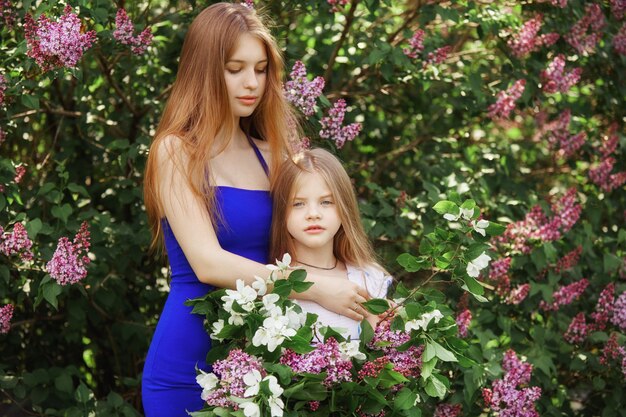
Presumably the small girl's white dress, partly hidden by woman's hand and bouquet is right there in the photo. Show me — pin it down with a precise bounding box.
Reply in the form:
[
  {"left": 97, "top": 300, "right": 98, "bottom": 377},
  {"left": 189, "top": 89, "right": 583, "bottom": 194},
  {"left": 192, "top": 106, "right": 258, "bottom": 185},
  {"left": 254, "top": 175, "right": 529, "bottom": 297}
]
[{"left": 298, "top": 265, "right": 393, "bottom": 340}]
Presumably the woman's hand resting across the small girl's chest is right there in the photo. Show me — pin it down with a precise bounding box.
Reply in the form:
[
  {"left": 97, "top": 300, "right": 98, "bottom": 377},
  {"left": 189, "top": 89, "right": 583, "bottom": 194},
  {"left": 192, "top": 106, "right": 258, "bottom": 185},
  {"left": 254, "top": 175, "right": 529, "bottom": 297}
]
[{"left": 307, "top": 274, "right": 371, "bottom": 321}]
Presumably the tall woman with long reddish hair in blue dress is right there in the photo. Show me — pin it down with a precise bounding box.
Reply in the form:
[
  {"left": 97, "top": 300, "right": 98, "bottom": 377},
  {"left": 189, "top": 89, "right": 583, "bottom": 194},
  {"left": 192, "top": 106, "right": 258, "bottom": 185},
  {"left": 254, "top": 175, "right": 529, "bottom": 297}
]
[{"left": 142, "top": 3, "right": 368, "bottom": 417}]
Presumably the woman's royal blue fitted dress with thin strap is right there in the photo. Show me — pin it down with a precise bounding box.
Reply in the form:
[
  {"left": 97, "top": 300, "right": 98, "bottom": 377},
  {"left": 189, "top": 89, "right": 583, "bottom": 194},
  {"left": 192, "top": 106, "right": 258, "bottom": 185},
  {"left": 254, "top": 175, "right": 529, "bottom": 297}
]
[{"left": 142, "top": 138, "right": 272, "bottom": 417}]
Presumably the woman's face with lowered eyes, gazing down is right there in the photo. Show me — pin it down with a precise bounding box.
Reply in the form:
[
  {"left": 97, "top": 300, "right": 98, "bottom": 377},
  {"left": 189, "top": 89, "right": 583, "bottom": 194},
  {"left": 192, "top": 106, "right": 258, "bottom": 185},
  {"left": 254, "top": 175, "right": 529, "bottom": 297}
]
[{"left": 224, "top": 33, "right": 268, "bottom": 118}]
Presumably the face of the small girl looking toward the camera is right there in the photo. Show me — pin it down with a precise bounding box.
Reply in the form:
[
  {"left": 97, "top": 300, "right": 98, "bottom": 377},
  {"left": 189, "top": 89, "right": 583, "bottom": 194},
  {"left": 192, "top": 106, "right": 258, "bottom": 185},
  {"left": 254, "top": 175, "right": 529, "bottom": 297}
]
[{"left": 287, "top": 172, "right": 341, "bottom": 253}]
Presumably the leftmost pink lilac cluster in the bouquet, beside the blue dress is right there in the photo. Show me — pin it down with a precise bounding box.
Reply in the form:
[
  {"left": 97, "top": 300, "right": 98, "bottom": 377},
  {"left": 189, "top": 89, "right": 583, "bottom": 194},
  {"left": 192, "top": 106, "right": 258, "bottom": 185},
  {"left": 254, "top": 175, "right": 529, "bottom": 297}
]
[{"left": 205, "top": 349, "right": 267, "bottom": 410}]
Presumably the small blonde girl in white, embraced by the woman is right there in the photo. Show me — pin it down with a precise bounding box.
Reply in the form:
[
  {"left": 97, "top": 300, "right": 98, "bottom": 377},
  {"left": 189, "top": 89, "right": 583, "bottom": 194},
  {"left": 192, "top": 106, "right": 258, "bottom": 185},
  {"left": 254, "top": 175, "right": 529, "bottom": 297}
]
[{"left": 271, "top": 149, "right": 391, "bottom": 340}]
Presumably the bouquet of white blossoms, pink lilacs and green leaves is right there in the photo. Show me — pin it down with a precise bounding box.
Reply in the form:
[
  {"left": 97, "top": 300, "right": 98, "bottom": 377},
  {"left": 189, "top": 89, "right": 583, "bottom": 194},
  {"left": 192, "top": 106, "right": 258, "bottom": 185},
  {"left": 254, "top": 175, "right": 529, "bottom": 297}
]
[{"left": 188, "top": 200, "right": 508, "bottom": 417}]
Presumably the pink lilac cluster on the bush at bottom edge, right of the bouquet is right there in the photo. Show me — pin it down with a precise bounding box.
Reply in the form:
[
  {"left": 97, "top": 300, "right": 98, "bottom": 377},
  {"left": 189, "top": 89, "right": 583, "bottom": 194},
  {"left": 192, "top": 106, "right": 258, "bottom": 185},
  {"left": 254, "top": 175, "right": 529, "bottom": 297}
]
[{"left": 483, "top": 350, "right": 541, "bottom": 417}]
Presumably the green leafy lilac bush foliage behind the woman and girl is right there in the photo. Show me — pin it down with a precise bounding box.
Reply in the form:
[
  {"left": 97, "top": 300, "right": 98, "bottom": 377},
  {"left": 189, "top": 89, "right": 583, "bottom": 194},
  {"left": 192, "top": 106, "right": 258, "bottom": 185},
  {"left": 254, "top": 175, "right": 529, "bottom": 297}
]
[{"left": 0, "top": 0, "right": 626, "bottom": 416}]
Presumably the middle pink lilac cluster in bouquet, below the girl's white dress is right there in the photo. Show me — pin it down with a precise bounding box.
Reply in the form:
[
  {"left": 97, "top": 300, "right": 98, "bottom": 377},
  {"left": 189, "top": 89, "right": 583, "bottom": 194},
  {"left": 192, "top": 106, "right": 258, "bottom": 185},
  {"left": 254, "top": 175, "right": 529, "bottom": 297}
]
[{"left": 280, "top": 337, "right": 352, "bottom": 387}]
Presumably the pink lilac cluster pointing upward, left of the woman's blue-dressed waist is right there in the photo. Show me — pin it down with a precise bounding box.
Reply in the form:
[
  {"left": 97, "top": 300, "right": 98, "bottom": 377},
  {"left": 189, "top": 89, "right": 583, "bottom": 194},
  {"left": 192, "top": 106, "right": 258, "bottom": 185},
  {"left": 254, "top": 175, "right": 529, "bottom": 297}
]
[{"left": 46, "top": 222, "right": 91, "bottom": 285}]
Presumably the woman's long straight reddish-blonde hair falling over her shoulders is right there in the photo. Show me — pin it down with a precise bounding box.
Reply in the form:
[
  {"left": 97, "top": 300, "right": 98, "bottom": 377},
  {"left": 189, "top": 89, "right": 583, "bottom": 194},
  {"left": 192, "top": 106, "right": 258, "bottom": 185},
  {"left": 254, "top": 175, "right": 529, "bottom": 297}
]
[{"left": 144, "top": 3, "right": 297, "bottom": 247}]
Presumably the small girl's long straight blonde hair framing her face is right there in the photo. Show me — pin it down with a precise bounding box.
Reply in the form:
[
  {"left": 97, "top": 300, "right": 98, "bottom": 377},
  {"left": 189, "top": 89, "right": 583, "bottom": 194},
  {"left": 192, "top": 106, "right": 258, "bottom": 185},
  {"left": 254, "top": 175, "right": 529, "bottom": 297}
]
[{"left": 270, "top": 149, "right": 376, "bottom": 267}]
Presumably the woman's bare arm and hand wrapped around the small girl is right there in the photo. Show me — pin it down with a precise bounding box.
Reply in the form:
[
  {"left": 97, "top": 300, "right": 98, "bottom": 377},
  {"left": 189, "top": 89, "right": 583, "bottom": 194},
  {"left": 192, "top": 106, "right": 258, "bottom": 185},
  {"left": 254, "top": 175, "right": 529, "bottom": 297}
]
[{"left": 157, "top": 136, "right": 369, "bottom": 320}]
